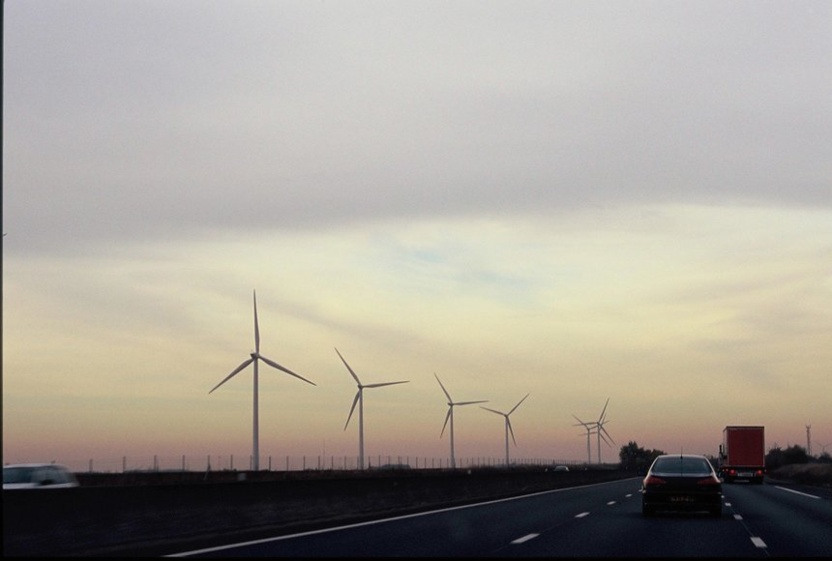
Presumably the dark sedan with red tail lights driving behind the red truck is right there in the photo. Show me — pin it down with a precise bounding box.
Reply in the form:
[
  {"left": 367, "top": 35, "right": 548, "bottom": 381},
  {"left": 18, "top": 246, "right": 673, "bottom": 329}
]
[{"left": 641, "top": 454, "right": 722, "bottom": 518}]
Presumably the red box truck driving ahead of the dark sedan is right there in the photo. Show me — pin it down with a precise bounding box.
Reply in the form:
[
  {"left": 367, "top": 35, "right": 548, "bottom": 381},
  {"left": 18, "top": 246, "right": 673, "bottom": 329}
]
[{"left": 719, "top": 426, "right": 766, "bottom": 483}]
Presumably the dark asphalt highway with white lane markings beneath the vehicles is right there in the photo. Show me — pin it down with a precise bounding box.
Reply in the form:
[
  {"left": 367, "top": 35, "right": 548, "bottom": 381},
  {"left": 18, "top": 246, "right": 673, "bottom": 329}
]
[{"left": 168, "top": 478, "right": 832, "bottom": 558}]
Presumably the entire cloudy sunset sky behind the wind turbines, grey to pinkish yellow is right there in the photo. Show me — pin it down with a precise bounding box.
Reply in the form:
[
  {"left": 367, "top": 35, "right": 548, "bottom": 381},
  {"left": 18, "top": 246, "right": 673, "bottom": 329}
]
[{"left": 2, "top": 0, "right": 832, "bottom": 469}]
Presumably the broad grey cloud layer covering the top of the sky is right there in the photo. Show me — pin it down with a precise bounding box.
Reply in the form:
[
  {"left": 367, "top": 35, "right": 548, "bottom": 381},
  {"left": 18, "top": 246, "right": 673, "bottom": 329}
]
[{"left": 4, "top": 1, "right": 832, "bottom": 251}]
